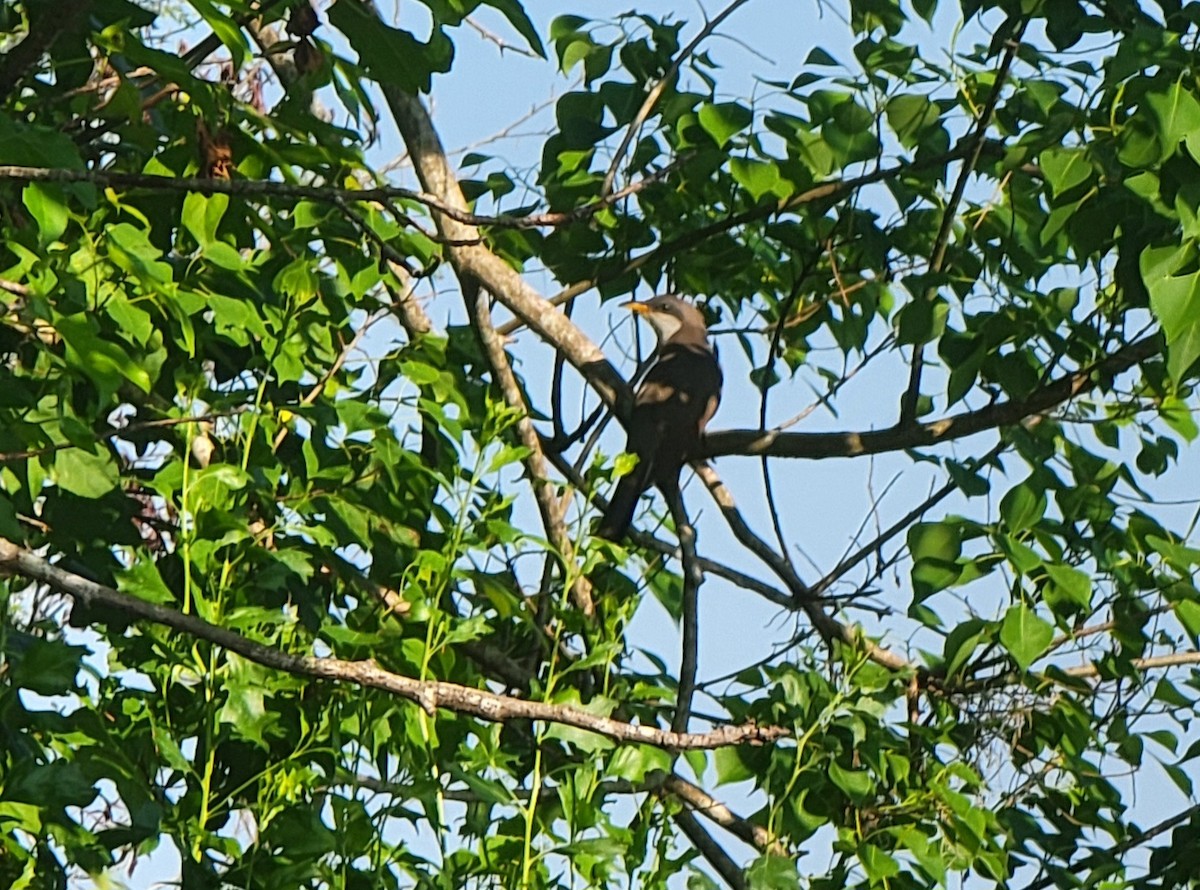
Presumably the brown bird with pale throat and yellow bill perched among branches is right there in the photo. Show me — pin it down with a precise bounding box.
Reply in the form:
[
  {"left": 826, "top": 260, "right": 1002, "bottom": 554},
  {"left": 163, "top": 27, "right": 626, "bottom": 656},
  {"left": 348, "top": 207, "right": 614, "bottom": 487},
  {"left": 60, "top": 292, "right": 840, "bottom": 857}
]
[{"left": 595, "top": 294, "right": 722, "bottom": 541}]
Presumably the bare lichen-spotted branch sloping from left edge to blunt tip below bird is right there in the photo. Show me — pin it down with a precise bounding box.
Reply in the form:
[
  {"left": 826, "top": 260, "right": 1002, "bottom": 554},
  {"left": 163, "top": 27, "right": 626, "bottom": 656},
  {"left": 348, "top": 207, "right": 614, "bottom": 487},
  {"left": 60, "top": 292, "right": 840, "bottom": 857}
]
[{"left": 0, "top": 539, "right": 788, "bottom": 751}]
